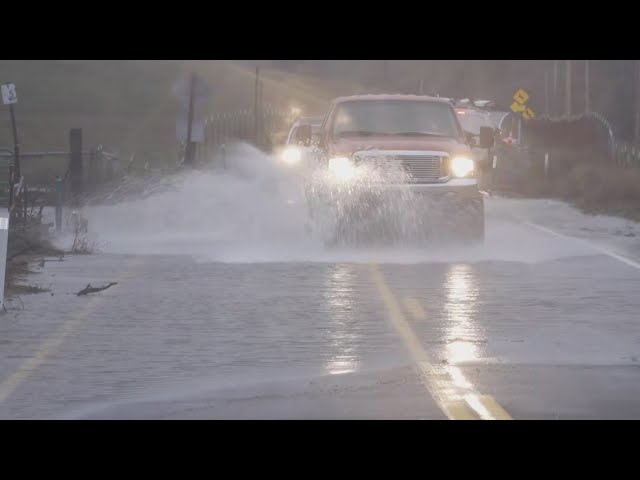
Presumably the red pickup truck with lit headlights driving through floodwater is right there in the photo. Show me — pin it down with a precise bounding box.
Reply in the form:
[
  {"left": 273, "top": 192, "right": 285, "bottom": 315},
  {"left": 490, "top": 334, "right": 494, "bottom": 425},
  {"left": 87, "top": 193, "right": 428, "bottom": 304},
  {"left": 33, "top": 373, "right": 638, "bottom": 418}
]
[{"left": 300, "top": 95, "right": 494, "bottom": 244}]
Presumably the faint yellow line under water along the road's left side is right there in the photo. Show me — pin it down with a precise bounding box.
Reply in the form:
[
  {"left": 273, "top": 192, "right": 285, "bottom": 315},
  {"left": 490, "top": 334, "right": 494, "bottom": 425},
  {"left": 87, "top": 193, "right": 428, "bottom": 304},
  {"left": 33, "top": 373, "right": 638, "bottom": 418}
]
[{"left": 0, "top": 259, "right": 144, "bottom": 403}]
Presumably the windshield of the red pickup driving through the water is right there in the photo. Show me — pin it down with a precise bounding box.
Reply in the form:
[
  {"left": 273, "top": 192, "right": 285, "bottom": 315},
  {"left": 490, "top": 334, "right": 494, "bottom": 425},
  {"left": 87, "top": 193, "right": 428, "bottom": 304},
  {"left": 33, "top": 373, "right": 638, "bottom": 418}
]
[{"left": 333, "top": 100, "right": 461, "bottom": 137}]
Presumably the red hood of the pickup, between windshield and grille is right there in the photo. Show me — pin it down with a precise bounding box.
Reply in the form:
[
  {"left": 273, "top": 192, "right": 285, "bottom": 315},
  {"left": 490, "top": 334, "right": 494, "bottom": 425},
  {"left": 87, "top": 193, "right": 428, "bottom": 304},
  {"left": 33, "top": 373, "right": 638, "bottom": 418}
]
[{"left": 331, "top": 136, "right": 470, "bottom": 156}]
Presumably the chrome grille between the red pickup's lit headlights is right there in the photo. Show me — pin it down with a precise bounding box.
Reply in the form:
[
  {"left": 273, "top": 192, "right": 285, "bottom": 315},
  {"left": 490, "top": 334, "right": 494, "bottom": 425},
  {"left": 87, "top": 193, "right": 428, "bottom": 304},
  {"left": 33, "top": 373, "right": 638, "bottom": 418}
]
[{"left": 354, "top": 152, "right": 449, "bottom": 183}]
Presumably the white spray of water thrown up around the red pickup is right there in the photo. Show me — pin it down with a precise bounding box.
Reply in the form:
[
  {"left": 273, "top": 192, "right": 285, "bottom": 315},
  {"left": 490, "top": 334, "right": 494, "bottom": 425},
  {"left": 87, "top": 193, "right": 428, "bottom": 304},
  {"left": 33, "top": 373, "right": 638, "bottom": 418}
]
[{"left": 80, "top": 145, "right": 586, "bottom": 263}]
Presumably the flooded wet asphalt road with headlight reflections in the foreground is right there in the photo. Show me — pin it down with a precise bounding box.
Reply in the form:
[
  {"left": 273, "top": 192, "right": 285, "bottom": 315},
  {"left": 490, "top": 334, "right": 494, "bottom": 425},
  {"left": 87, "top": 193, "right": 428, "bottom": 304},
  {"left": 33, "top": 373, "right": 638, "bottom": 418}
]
[{"left": 0, "top": 199, "right": 640, "bottom": 419}]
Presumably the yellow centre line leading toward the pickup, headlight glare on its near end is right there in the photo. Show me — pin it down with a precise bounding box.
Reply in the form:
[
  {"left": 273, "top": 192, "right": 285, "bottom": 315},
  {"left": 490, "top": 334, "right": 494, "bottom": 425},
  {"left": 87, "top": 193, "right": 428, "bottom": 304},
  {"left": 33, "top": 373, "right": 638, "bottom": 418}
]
[{"left": 370, "top": 264, "right": 511, "bottom": 420}]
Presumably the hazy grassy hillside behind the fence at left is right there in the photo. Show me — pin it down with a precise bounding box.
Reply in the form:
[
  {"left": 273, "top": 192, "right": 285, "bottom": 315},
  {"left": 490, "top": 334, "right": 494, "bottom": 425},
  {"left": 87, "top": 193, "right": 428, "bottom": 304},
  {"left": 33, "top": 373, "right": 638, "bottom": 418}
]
[{"left": 0, "top": 60, "right": 370, "bottom": 168}]
